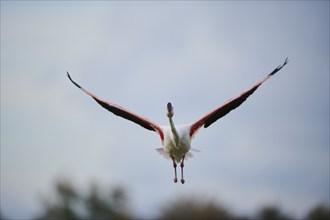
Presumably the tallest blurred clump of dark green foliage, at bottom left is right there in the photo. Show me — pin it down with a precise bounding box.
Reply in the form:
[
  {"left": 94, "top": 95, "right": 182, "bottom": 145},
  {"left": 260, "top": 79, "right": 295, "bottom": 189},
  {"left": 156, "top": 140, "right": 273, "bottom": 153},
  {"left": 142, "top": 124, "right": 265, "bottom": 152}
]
[{"left": 36, "top": 180, "right": 131, "bottom": 220}]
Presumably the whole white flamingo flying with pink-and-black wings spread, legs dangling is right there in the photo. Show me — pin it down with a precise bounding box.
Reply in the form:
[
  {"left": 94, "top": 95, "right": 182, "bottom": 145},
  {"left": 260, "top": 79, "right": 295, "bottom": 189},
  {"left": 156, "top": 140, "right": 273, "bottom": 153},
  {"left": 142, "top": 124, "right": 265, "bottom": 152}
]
[{"left": 67, "top": 58, "right": 288, "bottom": 184}]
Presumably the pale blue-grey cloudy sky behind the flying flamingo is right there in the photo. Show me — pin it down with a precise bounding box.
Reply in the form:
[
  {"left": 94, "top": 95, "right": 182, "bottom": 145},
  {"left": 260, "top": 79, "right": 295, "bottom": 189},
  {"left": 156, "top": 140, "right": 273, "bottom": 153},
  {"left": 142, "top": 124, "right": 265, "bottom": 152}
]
[{"left": 0, "top": 1, "right": 330, "bottom": 218}]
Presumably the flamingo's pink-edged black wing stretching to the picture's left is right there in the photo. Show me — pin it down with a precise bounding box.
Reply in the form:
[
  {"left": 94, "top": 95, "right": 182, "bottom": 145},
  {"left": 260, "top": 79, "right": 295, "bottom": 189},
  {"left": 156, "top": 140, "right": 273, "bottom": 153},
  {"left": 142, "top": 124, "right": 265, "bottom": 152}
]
[{"left": 67, "top": 72, "right": 164, "bottom": 141}]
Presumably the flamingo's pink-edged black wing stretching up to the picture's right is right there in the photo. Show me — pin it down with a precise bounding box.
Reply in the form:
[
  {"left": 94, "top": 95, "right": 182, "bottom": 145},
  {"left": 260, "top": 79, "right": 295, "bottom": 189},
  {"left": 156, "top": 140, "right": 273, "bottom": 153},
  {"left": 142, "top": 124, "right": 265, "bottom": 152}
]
[{"left": 190, "top": 58, "right": 288, "bottom": 137}]
